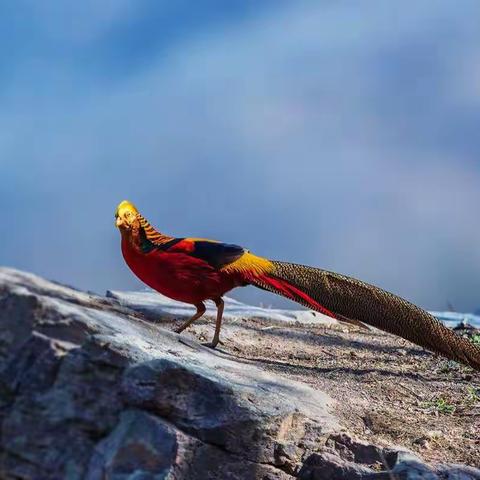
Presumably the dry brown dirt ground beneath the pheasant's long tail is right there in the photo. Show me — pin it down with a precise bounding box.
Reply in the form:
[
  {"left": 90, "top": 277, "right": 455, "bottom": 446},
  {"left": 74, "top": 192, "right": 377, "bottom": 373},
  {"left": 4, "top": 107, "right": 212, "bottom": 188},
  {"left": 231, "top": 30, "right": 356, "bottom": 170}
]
[{"left": 162, "top": 319, "right": 480, "bottom": 467}]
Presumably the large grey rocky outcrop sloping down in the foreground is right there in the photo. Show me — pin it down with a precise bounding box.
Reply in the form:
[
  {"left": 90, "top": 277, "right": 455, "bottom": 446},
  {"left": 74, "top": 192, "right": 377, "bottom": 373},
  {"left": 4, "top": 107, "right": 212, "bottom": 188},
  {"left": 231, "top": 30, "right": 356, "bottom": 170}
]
[{"left": 0, "top": 269, "right": 480, "bottom": 480}]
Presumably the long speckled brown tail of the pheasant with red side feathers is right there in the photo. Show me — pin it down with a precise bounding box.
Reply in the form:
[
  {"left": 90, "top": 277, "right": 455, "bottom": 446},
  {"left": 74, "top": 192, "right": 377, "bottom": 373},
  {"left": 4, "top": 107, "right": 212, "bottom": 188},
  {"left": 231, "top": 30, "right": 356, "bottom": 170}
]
[{"left": 249, "top": 261, "right": 480, "bottom": 371}]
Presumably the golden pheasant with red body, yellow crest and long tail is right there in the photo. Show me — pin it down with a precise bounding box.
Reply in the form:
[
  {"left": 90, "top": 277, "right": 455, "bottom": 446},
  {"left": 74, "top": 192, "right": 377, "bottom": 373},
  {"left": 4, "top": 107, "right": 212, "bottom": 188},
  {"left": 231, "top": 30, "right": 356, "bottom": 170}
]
[{"left": 115, "top": 200, "right": 480, "bottom": 371}]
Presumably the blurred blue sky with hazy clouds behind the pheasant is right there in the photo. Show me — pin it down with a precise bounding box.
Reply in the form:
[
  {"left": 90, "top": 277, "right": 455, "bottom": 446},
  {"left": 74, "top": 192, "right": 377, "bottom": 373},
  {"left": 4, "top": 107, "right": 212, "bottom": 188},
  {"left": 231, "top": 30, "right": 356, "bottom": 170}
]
[{"left": 0, "top": 0, "right": 480, "bottom": 311}]
